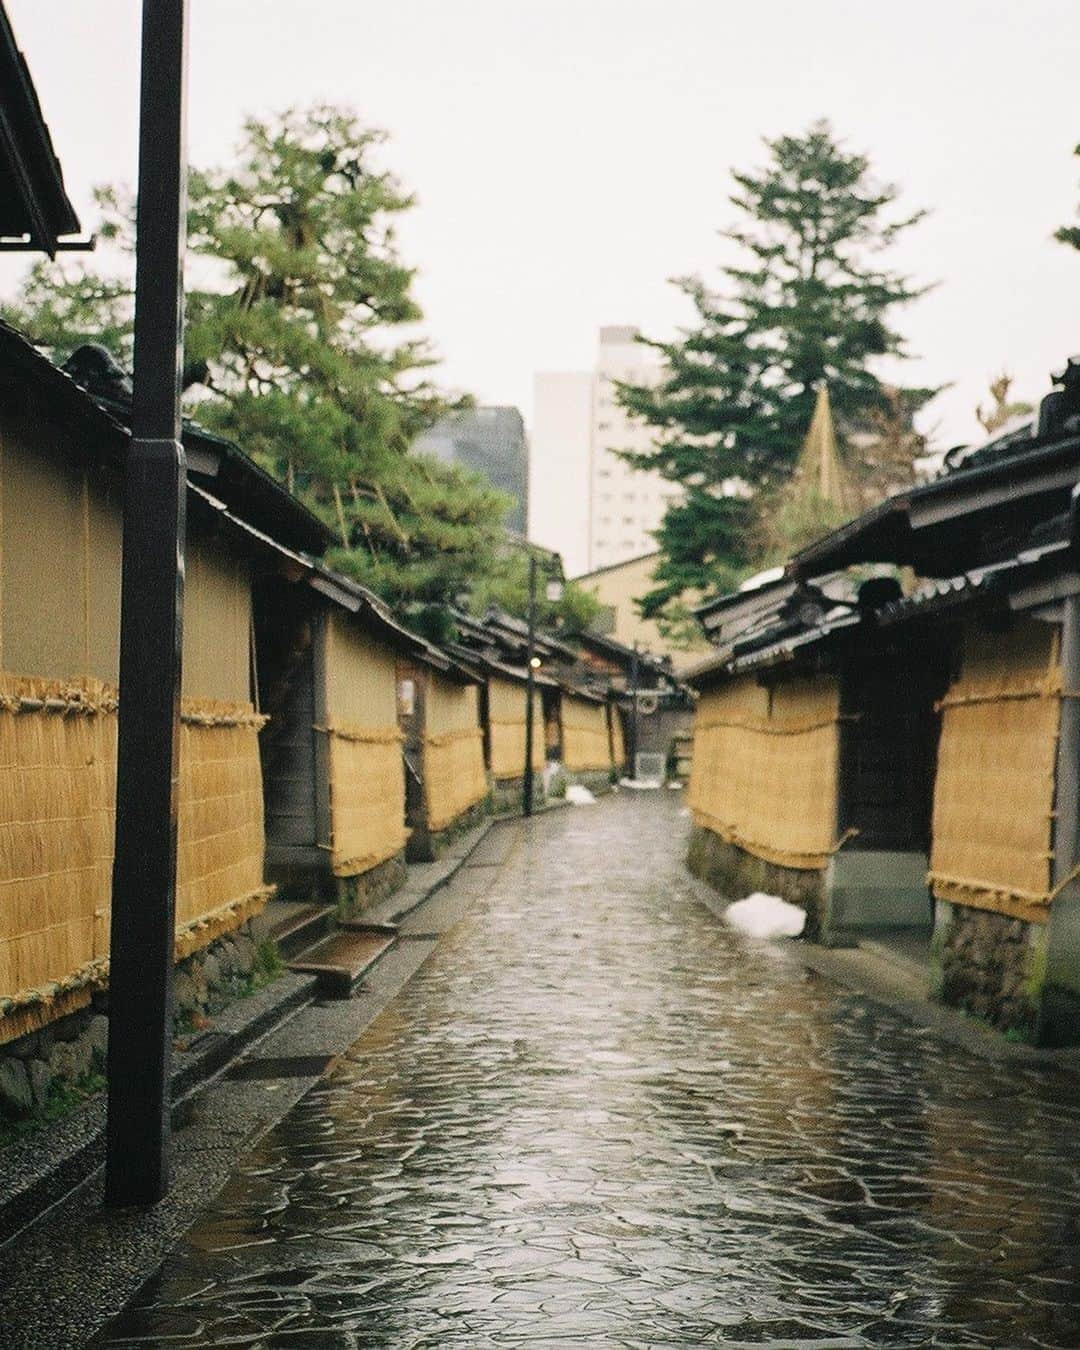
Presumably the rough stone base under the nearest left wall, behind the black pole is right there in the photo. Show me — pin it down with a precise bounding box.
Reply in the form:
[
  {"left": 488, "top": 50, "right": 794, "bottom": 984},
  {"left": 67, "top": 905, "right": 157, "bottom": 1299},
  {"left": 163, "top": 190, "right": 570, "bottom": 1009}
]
[{"left": 0, "top": 922, "right": 263, "bottom": 1119}]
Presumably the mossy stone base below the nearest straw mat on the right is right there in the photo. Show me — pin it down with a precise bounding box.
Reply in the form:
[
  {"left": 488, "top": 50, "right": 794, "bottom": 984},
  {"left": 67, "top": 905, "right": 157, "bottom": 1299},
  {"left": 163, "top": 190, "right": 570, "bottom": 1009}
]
[{"left": 934, "top": 900, "right": 1048, "bottom": 1041}]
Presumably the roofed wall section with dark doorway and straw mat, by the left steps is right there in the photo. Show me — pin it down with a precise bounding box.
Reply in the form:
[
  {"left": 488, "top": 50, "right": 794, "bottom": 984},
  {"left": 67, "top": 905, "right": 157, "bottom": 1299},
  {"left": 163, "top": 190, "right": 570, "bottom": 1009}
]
[{"left": 255, "top": 558, "right": 437, "bottom": 911}]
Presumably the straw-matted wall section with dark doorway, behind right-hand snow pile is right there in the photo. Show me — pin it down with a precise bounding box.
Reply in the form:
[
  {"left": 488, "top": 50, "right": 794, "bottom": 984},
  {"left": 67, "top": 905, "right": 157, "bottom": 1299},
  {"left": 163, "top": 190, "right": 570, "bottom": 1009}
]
[{"left": 689, "top": 581, "right": 944, "bottom": 942}]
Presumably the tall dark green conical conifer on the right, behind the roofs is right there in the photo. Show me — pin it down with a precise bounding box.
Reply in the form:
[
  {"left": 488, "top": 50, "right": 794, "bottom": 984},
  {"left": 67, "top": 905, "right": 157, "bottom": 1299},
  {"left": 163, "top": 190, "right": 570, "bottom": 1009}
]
[{"left": 620, "top": 122, "right": 936, "bottom": 616}]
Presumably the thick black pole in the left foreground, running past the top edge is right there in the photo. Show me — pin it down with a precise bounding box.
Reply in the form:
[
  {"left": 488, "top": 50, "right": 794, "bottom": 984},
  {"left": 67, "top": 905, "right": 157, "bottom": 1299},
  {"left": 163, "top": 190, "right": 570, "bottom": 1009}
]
[{"left": 105, "top": 0, "right": 188, "bottom": 1206}]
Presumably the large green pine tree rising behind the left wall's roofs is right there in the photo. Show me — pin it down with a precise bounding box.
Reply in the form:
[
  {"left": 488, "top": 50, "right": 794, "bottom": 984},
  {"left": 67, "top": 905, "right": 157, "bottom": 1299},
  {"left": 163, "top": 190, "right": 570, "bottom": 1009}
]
[{"left": 3, "top": 107, "right": 537, "bottom": 628}]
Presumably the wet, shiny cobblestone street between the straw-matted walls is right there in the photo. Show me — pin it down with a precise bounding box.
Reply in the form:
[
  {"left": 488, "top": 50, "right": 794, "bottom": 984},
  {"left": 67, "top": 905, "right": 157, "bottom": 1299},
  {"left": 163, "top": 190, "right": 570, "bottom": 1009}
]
[{"left": 103, "top": 794, "right": 1080, "bottom": 1350}]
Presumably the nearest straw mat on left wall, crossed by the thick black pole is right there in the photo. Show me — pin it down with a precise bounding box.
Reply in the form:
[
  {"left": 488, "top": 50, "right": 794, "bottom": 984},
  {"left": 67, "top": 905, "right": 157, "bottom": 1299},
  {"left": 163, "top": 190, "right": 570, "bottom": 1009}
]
[{"left": 0, "top": 675, "right": 269, "bottom": 1042}]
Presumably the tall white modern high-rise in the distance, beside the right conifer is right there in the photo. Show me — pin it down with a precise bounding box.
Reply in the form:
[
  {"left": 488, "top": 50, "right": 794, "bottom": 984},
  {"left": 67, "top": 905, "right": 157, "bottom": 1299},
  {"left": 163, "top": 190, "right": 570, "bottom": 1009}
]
[{"left": 528, "top": 327, "right": 679, "bottom": 576}]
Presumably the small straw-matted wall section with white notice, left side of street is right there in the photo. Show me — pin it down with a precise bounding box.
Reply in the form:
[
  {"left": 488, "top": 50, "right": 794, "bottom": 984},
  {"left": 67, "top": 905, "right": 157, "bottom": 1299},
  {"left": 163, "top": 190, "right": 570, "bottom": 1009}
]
[{"left": 397, "top": 648, "right": 489, "bottom": 861}]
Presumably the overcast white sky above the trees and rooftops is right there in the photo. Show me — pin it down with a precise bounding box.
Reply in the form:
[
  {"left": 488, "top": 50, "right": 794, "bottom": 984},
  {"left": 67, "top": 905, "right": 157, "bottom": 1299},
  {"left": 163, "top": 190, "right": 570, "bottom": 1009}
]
[{"left": 0, "top": 0, "right": 1080, "bottom": 443}]
